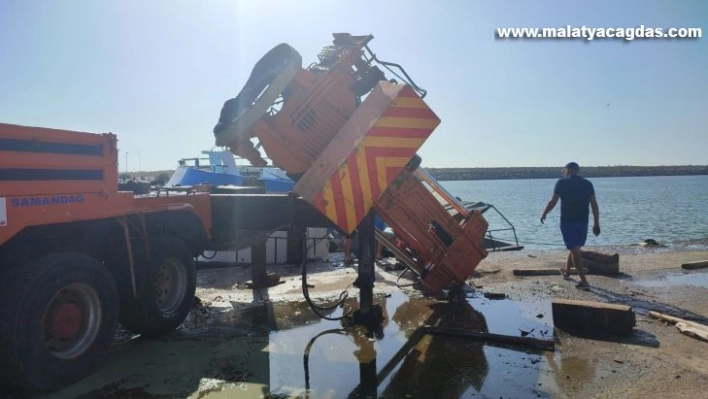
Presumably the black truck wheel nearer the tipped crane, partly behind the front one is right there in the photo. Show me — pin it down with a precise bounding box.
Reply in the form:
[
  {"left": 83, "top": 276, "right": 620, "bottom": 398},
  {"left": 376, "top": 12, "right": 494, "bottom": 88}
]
[{"left": 120, "top": 237, "right": 197, "bottom": 336}]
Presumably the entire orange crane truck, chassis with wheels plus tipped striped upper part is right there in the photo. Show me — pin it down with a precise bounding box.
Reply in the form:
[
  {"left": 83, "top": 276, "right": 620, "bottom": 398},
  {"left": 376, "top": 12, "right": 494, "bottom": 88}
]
[{"left": 0, "top": 33, "right": 487, "bottom": 390}]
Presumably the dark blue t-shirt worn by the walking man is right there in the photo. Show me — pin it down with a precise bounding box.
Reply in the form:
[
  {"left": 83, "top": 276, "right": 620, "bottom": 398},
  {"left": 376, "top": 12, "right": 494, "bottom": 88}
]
[{"left": 553, "top": 175, "right": 595, "bottom": 224}]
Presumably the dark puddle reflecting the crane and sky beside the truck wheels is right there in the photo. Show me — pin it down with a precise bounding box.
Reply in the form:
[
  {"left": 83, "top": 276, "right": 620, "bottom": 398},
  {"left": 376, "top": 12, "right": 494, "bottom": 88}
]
[{"left": 31, "top": 292, "right": 576, "bottom": 399}]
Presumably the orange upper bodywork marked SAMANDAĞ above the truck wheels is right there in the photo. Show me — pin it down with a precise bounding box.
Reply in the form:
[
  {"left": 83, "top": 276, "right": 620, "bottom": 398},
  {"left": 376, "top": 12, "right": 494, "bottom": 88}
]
[{"left": 0, "top": 123, "right": 211, "bottom": 244}]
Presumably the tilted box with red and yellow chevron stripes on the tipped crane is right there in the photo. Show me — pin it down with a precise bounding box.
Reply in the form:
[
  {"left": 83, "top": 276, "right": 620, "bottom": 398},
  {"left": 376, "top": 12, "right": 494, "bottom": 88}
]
[{"left": 294, "top": 82, "right": 440, "bottom": 232}]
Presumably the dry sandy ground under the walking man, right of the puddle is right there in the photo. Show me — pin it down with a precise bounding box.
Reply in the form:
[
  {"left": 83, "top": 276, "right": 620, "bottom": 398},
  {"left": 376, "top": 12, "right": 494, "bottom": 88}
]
[{"left": 473, "top": 245, "right": 708, "bottom": 398}]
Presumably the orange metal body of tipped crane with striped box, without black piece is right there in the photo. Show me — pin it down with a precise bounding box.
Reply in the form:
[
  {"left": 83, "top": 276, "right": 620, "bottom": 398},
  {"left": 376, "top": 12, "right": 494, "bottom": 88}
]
[{"left": 216, "top": 35, "right": 487, "bottom": 292}]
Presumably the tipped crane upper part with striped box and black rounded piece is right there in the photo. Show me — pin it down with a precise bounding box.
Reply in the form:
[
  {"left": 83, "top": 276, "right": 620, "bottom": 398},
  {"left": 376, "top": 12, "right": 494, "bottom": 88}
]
[{"left": 213, "top": 33, "right": 488, "bottom": 300}]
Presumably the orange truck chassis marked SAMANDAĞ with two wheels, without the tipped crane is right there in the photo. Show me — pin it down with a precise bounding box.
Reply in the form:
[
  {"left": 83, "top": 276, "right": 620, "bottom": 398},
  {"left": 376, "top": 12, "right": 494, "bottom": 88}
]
[{"left": 0, "top": 123, "right": 330, "bottom": 391}]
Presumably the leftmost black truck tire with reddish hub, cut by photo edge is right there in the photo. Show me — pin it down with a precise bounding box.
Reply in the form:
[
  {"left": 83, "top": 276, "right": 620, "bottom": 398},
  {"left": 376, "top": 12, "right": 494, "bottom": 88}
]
[{"left": 0, "top": 253, "right": 118, "bottom": 391}]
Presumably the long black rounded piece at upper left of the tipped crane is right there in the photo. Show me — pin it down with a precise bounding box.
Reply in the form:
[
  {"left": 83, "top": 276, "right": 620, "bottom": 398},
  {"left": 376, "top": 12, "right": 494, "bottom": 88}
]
[{"left": 214, "top": 43, "right": 302, "bottom": 146}]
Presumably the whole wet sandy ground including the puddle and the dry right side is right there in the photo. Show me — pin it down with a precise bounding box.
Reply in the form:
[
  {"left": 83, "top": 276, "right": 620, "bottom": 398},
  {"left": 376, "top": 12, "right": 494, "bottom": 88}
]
[{"left": 6, "top": 242, "right": 708, "bottom": 398}]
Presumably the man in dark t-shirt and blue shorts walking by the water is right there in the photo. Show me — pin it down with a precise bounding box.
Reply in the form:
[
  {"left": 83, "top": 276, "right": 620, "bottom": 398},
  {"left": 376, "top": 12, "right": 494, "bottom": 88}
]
[{"left": 541, "top": 162, "right": 600, "bottom": 290}]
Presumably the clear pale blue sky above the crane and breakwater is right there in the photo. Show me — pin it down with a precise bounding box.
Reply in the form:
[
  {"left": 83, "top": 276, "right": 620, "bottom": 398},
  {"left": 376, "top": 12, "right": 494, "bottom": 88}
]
[{"left": 0, "top": 0, "right": 708, "bottom": 171}]
